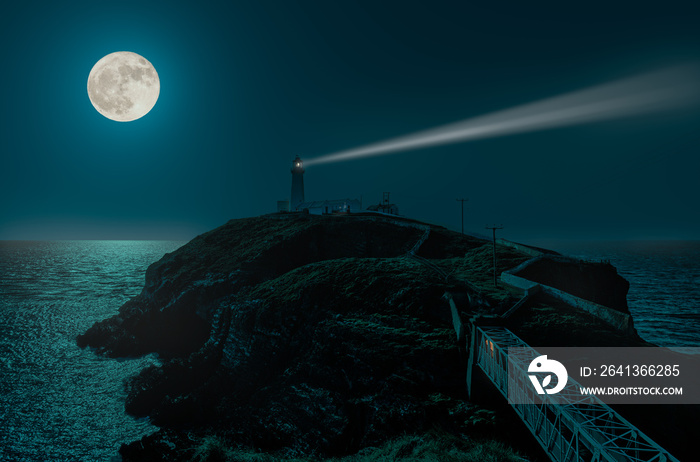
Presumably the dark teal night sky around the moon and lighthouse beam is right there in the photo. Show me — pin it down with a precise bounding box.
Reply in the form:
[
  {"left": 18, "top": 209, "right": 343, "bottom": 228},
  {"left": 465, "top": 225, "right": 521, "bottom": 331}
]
[{"left": 0, "top": 0, "right": 700, "bottom": 241}]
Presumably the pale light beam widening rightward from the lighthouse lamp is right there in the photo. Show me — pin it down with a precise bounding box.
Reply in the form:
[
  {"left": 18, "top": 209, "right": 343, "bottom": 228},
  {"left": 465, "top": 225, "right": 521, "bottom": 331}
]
[{"left": 305, "top": 65, "right": 700, "bottom": 166}]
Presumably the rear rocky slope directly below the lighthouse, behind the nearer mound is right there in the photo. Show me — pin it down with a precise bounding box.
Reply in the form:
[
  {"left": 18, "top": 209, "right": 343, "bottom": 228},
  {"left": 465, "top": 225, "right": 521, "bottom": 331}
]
[{"left": 78, "top": 216, "right": 421, "bottom": 356}]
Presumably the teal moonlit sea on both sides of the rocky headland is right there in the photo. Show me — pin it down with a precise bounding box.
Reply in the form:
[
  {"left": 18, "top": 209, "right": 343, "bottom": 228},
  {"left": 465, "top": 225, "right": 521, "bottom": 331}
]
[{"left": 0, "top": 241, "right": 700, "bottom": 461}]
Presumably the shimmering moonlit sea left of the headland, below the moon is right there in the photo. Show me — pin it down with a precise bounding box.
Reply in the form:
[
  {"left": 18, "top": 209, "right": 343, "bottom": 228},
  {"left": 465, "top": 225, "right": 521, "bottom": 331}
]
[{"left": 0, "top": 241, "right": 183, "bottom": 461}]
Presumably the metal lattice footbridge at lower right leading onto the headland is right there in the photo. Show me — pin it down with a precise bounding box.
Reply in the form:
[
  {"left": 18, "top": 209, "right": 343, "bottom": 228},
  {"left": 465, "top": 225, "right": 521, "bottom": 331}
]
[{"left": 472, "top": 325, "right": 678, "bottom": 462}]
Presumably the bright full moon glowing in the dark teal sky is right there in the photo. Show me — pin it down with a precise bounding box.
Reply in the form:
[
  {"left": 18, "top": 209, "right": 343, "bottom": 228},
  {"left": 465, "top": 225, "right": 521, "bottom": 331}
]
[{"left": 88, "top": 51, "right": 160, "bottom": 122}]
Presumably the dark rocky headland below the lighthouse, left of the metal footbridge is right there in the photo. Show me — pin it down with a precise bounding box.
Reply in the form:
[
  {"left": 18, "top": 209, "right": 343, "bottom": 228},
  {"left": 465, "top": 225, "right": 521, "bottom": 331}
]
[{"left": 78, "top": 214, "right": 652, "bottom": 460}]
